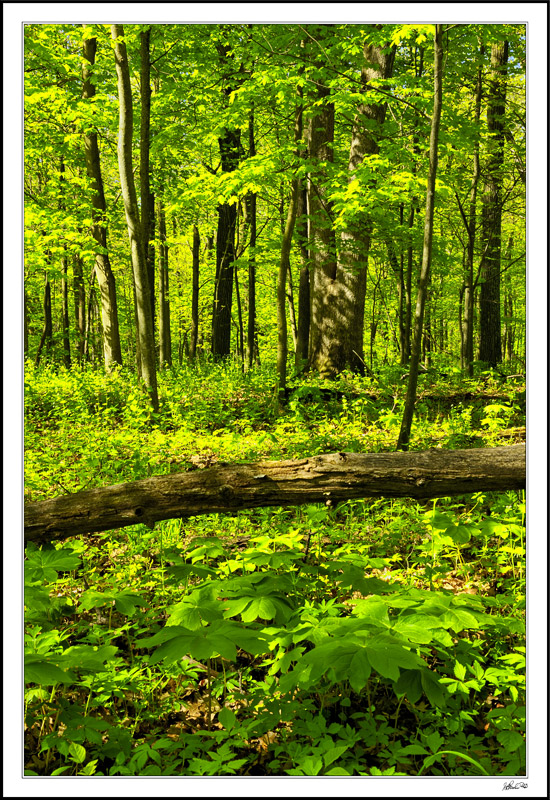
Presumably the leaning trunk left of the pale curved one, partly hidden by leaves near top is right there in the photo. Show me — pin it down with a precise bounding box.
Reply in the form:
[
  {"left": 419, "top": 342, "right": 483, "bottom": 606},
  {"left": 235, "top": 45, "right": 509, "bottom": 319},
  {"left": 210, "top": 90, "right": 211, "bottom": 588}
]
[{"left": 82, "top": 30, "right": 122, "bottom": 371}]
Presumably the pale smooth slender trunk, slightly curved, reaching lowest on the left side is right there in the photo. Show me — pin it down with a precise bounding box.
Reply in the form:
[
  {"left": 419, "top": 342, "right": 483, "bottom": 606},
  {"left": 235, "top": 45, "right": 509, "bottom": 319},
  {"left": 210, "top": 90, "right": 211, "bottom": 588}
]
[{"left": 111, "top": 25, "right": 158, "bottom": 411}]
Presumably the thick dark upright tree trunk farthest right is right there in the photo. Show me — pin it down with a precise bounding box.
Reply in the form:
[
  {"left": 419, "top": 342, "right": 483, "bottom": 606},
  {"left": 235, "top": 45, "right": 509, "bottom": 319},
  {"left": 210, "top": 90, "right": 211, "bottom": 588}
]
[{"left": 479, "top": 41, "right": 508, "bottom": 367}]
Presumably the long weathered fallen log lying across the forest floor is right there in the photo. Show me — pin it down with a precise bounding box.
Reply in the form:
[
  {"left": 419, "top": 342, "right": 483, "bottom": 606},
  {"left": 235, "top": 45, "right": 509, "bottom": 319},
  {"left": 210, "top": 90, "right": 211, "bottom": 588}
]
[{"left": 25, "top": 444, "right": 525, "bottom": 542}]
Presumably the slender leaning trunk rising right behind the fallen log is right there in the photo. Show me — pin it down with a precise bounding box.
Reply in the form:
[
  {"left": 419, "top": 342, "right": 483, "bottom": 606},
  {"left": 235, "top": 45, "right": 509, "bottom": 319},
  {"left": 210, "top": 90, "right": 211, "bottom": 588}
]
[{"left": 397, "top": 25, "right": 443, "bottom": 450}]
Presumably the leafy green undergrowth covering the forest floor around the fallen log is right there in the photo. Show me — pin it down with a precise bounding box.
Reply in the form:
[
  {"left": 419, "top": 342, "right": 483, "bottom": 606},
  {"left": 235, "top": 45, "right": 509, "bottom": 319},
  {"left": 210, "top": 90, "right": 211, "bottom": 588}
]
[{"left": 25, "top": 364, "right": 525, "bottom": 776}]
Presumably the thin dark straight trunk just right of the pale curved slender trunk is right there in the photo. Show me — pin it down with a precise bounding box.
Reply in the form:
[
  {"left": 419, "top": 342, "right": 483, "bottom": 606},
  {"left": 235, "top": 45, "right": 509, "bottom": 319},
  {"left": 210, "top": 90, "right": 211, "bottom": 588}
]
[{"left": 139, "top": 28, "right": 155, "bottom": 337}]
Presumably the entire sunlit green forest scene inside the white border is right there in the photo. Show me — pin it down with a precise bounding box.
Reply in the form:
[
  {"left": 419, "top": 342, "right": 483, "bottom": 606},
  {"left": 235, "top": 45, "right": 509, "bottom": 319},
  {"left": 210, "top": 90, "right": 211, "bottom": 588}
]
[{"left": 23, "top": 23, "right": 527, "bottom": 777}]
